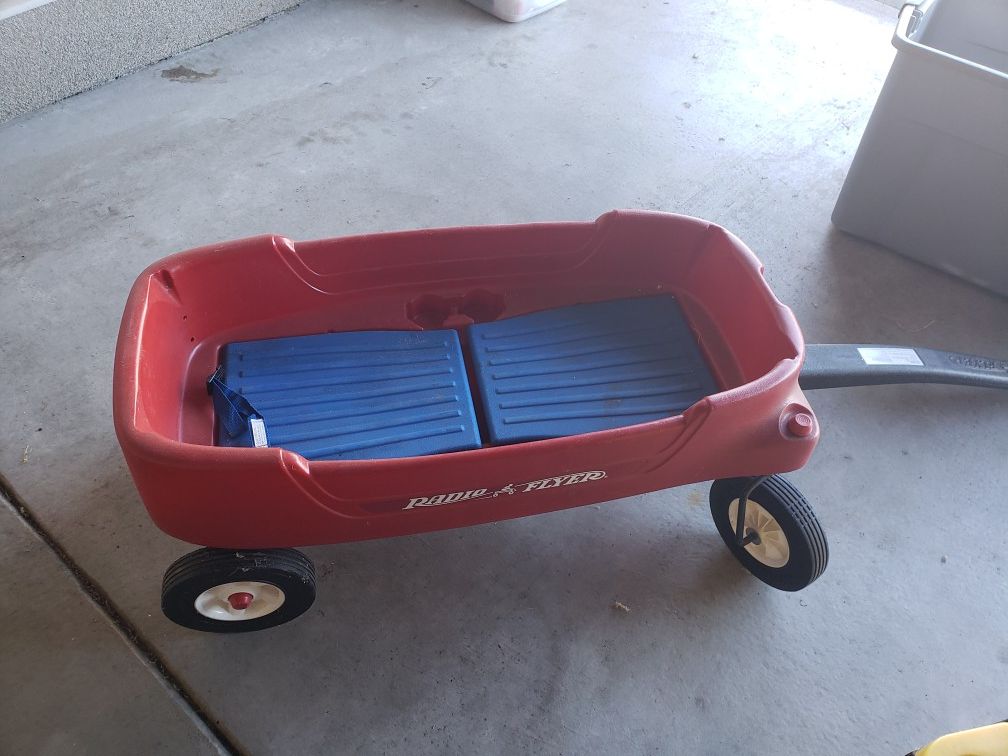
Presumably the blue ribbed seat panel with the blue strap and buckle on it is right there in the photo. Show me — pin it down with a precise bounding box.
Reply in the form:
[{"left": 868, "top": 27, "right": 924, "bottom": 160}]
[{"left": 211, "top": 331, "right": 481, "bottom": 460}]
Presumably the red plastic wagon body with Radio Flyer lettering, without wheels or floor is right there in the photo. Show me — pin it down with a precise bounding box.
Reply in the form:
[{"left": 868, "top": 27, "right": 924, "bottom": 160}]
[{"left": 113, "top": 212, "right": 818, "bottom": 548}]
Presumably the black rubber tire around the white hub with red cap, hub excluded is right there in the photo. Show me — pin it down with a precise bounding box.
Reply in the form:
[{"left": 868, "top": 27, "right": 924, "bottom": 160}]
[{"left": 161, "top": 548, "right": 316, "bottom": 633}]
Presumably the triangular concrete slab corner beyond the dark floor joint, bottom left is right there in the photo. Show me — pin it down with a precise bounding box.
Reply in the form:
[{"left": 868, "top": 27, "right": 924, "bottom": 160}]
[{"left": 0, "top": 507, "right": 221, "bottom": 754}]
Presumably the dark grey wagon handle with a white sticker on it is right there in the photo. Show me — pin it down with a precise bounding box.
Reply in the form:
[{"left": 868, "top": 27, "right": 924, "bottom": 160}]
[{"left": 798, "top": 344, "right": 1008, "bottom": 389}]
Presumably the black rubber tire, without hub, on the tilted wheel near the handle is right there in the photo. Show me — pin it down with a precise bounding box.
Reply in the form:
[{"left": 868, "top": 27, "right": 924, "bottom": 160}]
[{"left": 711, "top": 475, "right": 830, "bottom": 591}]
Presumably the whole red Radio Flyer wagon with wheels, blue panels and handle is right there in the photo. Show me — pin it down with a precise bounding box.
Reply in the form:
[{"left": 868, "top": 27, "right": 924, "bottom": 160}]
[{"left": 113, "top": 212, "right": 1008, "bottom": 632}]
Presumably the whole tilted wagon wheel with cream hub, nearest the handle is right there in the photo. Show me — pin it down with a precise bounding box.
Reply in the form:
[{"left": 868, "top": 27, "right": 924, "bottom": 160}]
[{"left": 711, "top": 475, "right": 830, "bottom": 591}]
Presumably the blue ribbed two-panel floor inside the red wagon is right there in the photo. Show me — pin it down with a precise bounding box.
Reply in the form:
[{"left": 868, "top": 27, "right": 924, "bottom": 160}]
[{"left": 214, "top": 294, "right": 717, "bottom": 460}]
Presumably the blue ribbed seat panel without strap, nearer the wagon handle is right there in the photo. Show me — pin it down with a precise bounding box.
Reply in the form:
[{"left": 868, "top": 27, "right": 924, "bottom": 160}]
[{"left": 469, "top": 295, "right": 718, "bottom": 444}]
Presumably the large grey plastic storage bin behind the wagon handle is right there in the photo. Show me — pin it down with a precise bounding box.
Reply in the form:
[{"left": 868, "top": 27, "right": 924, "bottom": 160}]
[{"left": 833, "top": 0, "right": 1008, "bottom": 295}]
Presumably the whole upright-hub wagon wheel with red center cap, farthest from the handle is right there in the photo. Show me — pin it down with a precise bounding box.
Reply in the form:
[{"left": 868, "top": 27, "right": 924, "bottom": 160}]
[{"left": 161, "top": 548, "right": 316, "bottom": 633}]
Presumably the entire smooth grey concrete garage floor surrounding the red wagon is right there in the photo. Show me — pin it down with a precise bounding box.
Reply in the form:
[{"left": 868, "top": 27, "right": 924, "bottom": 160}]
[{"left": 0, "top": 0, "right": 1008, "bottom": 754}]
